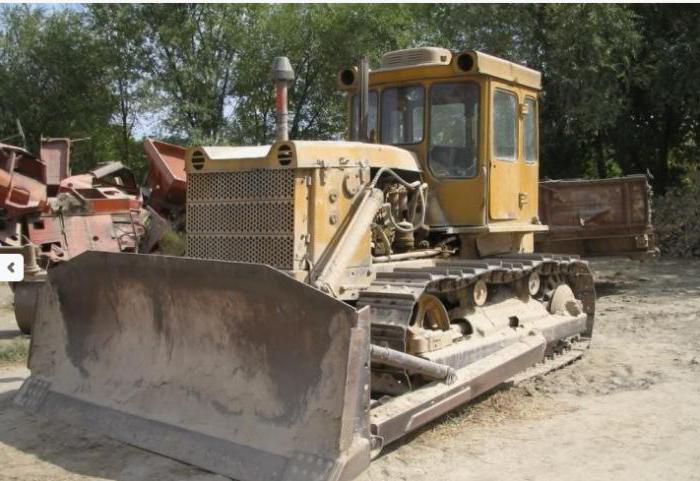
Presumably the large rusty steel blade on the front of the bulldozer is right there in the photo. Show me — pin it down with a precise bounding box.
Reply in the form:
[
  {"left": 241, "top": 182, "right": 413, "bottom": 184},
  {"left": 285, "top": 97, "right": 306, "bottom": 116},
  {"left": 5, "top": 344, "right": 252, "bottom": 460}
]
[{"left": 16, "top": 251, "right": 370, "bottom": 481}]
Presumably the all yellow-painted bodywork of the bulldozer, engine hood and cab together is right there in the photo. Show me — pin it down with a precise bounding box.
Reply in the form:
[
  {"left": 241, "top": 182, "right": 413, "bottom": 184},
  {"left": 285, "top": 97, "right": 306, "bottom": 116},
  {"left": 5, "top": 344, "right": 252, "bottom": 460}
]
[{"left": 186, "top": 47, "right": 545, "bottom": 284}]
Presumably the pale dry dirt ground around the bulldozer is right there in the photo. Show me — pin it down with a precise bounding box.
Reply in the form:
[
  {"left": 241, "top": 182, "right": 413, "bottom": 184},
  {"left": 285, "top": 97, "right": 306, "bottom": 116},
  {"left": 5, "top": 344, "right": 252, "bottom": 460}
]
[{"left": 0, "top": 260, "right": 700, "bottom": 481}]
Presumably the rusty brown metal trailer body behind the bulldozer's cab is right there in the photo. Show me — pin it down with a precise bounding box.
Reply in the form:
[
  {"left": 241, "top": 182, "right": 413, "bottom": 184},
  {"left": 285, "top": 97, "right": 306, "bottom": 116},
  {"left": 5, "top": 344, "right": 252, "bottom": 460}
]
[{"left": 536, "top": 175, "right": 656, "bottom": 256}]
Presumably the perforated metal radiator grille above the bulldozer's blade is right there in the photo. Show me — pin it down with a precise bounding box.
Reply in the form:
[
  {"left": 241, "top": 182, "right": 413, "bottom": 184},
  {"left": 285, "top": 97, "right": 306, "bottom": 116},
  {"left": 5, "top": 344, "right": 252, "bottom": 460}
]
[{"left": 187, "top": 170, "right": 294, "bottom": 270}]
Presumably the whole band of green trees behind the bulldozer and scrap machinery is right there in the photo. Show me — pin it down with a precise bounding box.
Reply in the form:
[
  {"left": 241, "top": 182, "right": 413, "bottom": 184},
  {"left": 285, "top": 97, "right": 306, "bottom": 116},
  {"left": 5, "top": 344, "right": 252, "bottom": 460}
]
[{"left": 0, "top": 4, "right": 700, "bottom": 193}]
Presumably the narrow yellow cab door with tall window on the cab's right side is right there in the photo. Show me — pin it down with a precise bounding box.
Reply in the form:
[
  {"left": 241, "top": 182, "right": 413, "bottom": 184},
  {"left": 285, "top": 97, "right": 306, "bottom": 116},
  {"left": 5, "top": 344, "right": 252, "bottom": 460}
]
[{"left": 489, "top": 82, "right": 521, "bottom": 220}]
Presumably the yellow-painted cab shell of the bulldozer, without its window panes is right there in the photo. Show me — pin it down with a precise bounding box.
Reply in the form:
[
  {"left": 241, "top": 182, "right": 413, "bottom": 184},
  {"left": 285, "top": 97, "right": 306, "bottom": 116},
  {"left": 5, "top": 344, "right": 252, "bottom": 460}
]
[{"left": 348, "top": 47, "right": 542, "bottom": 232}]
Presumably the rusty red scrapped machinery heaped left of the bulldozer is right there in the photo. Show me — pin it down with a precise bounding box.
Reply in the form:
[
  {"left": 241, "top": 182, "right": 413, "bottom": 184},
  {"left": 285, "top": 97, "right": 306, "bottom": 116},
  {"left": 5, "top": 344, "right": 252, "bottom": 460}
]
[{"left": 0, "top": 138, "right": 184, "bottom": 334}]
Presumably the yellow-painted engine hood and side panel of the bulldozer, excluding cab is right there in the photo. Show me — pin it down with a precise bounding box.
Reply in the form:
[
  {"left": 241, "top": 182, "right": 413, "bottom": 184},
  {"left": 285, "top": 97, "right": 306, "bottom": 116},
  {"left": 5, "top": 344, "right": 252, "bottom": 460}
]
[{"left": 186, "top": 142, "right": 374, "bottom": 299}]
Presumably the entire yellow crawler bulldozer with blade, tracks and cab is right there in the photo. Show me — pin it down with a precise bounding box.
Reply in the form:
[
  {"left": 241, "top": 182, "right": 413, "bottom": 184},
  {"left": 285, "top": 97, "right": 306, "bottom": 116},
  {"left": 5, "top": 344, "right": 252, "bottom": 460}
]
[{"left": 16, "top": 48, "right": 595, "bottom": 481}]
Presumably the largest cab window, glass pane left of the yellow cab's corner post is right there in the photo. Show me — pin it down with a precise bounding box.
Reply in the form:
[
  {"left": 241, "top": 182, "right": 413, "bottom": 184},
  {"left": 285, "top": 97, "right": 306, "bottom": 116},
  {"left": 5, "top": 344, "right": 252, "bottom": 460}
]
[{"left": 428, "top": 82, "right": 479, "bottom": 177}]
